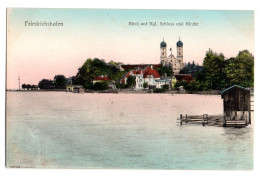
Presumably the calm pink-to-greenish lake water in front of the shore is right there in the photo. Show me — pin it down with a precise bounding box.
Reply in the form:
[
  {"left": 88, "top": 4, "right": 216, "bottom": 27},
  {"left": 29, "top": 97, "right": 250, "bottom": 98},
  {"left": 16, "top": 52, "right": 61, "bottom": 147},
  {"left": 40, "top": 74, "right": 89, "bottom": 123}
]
[{"left": 6, "top": 92, "right": 253, "bottom": 169}]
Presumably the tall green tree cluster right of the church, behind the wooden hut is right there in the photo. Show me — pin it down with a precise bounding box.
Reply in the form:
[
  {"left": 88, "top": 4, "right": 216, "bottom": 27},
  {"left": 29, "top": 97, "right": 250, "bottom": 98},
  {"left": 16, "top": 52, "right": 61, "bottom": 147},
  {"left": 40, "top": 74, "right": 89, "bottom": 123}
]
[{"left": 175, "top": 49, "right": 254, "bottom": 91}]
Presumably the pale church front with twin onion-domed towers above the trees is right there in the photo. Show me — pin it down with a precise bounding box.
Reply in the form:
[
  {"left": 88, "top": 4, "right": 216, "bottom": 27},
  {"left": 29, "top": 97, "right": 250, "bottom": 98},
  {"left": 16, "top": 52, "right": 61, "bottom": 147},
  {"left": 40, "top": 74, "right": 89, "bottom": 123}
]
[{"left": 160, "top": 39, "right": 184, "bottom": 74}]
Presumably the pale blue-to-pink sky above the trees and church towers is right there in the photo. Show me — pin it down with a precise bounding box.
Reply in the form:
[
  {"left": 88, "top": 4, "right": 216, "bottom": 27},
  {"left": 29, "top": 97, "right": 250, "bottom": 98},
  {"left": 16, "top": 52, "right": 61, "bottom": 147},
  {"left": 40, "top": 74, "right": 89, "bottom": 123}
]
[{"left": 7, "top": 8, "right": 254, "bottom": 89}]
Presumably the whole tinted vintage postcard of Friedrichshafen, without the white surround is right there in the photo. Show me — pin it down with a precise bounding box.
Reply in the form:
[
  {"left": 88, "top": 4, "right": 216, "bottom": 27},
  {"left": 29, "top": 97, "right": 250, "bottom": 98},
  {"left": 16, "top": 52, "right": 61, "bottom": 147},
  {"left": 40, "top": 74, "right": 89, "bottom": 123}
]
[{"left": 6, "top": 8, "right": 254, "bottom": 170}]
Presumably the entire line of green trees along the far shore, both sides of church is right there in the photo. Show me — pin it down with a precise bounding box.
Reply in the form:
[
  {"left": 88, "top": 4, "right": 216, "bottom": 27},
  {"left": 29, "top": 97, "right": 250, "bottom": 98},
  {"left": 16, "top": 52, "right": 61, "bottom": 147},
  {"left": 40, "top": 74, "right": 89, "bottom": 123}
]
[{"left": 33, "top": 49, "right": 254, "bottom": 91}]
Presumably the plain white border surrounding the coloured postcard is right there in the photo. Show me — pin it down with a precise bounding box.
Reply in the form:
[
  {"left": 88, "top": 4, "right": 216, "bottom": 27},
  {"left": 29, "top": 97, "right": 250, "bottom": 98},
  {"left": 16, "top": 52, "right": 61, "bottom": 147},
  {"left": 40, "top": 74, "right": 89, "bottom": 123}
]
[{"left": 0, "top": 0, "right": 260, "bottom": 175}]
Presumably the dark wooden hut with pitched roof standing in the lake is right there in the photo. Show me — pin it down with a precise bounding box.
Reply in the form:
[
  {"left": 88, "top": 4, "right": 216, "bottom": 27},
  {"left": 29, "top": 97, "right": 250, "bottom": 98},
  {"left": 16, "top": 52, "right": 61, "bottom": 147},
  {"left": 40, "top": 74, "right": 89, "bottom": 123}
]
[{"left": 221, "top": 85, "right": 251, "bottom": 127}]
